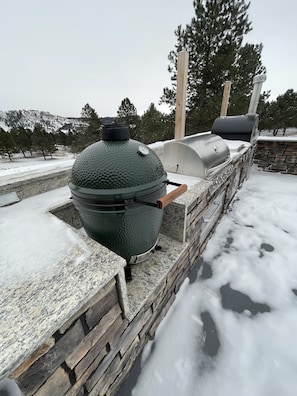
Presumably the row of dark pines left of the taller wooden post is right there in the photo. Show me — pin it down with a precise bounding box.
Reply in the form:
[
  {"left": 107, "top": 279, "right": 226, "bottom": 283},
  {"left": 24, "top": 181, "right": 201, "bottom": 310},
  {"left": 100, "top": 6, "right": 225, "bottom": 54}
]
[{"left": 0, "top": 98, "right": 174, "bottom": 160}]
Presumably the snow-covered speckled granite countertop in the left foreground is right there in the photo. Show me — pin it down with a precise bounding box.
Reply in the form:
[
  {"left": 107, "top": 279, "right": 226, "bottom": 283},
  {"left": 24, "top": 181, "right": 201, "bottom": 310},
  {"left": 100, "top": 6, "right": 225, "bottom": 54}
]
[{"left": 0, "top": 187, "right": 125, "bottom": 379}]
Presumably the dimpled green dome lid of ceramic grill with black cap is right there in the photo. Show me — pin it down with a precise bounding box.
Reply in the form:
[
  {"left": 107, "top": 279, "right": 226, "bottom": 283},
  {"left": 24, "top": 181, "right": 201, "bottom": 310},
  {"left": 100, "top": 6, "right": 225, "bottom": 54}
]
[{"left": 70, "top": 124, "right": 167, "bottom": 194}]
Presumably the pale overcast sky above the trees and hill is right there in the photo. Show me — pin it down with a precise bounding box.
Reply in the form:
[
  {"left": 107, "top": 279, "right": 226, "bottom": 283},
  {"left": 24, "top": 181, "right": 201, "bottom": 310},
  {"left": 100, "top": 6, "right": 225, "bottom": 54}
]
[{"left": 0, "top": 0, "right": 297, "bottom": 117}]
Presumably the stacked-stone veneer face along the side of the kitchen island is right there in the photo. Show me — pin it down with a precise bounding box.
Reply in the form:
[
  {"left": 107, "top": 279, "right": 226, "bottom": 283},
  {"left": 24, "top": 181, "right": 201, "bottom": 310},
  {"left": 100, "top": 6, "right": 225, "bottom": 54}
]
[{"left": 9, "top": 148, "right": 253, "bottom": 396}]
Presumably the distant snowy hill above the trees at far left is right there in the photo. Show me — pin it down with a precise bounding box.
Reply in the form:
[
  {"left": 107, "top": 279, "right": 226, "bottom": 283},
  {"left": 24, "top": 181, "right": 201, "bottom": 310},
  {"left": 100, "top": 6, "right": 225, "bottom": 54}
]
[{"left": 0, "top": 110, "right": 114, "bottom": 133}]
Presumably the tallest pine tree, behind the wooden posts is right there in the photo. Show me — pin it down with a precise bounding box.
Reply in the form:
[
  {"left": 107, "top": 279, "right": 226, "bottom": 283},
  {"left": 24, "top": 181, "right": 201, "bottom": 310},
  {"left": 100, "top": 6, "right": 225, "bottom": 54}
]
[{"left": 161, "top": 0, "right": 264, "bottom": 132}]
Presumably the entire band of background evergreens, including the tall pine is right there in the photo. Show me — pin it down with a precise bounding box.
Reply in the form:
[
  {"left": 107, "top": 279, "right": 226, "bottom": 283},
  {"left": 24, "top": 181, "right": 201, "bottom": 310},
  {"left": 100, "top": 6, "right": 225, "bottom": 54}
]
[{"left": 0, "top": 0, "right": 297, "bottom": 160}]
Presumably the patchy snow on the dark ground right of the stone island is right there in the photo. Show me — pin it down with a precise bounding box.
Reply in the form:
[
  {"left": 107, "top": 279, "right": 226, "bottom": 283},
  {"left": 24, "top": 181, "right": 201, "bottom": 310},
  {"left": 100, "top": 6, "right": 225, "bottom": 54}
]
[{"left": 132, "top": 168, "right": 297, "bottom": 396}]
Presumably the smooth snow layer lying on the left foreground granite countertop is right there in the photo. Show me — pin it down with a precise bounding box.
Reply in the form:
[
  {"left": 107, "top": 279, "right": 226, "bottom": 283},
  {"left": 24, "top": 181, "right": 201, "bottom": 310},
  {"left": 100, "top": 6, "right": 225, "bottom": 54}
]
[{"left": 0, "top": 186, "right": 88, "bottom": 283}]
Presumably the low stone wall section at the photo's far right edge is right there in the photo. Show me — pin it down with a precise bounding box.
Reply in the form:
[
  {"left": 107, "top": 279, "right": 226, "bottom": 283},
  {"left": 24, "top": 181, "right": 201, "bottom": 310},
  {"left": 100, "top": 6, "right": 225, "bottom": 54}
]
[{"left": 254, "top": 138, "right": 297, "bottom": 175}]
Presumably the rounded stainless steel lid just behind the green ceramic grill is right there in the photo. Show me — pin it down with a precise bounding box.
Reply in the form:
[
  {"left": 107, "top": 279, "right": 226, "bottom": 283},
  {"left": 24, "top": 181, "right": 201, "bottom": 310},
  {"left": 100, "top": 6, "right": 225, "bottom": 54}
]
[{"left": 163, "top": 133, "right": 230, "bottom": 178}]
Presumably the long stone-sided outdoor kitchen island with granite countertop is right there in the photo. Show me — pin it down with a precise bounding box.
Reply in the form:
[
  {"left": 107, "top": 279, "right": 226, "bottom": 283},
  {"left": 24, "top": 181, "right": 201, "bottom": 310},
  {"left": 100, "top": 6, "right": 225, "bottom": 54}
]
[{"left": 0, "top": 135, "right": 254, "bottom": 395}]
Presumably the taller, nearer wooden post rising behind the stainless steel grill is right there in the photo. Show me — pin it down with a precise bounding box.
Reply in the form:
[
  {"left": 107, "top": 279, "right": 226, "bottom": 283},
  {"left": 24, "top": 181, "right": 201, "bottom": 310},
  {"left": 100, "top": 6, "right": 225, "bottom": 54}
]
[{"left": 174, "top": 51, "right": 189, "bottom": 140}]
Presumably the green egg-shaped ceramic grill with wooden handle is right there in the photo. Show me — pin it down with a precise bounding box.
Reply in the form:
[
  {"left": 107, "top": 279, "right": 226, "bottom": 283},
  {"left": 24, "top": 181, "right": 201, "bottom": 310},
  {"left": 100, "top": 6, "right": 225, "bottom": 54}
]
[{"left": 69, "top": 124, "right": 186, "bottom": 280}]
